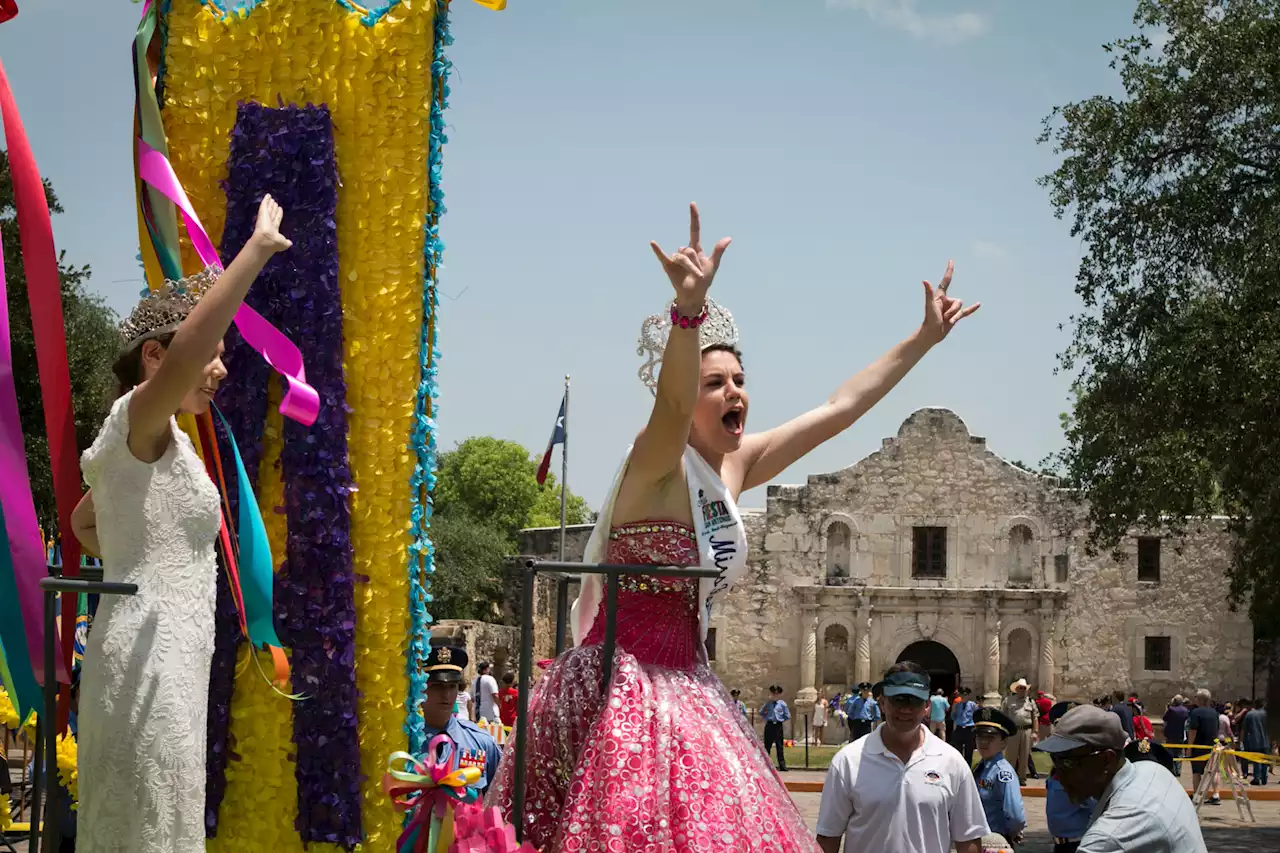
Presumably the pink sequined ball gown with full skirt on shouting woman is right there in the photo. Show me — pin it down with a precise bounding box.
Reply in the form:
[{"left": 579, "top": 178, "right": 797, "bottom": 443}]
[{"left": 489, "top": 521, "right": 817, "bottom": 853}]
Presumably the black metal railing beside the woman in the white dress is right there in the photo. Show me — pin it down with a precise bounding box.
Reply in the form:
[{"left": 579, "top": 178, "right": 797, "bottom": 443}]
[{"left": 28, "top": 566, "right": 138, "bottom": 853}]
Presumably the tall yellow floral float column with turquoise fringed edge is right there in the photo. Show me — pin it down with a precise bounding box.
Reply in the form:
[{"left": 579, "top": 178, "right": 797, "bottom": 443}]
[{"left": 159, "top": 0, "right": 468, "bottom": 853}]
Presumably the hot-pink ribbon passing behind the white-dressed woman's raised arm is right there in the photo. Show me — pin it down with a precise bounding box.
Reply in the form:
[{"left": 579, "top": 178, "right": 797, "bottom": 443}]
[{"left": 138, "top": 140, "right": 320, "bottom": 427}]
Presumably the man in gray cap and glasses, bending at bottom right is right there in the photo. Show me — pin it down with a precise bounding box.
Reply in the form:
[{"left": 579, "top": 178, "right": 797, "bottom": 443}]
[{"left": 1036, "top": 704, "right": 1207, "bottom": 853}]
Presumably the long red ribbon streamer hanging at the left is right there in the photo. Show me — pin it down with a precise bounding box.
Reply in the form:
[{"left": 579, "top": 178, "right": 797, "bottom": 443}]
[{"left": 0, "top": 63, "right": 82, "bottom": 691}]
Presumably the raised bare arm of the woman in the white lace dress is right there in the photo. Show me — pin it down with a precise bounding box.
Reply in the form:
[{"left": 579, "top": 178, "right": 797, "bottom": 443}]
[{"left": 129, "top": 196, "right": 293, "bottom": 461}]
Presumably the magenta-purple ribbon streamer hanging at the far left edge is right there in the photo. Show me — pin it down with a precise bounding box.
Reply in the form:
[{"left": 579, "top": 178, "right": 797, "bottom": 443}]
[{"left": 0, "top": 233, "right": 49, "bottom": 683}]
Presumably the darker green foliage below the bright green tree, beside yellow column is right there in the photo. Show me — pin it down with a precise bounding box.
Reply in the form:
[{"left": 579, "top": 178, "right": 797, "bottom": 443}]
[{"left": 428, "top": 514, "right": 511, "bottom": 621}]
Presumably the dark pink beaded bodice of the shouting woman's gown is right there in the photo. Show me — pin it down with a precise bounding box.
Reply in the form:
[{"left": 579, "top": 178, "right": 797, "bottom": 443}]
[{"left": 582, "top": 521, "right": 701, "bottom": 670}]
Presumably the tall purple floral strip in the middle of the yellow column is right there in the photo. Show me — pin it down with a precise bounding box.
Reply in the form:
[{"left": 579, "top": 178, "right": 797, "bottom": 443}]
[{"left": 211, "top": 97, "right": 364, "bottom": 850}]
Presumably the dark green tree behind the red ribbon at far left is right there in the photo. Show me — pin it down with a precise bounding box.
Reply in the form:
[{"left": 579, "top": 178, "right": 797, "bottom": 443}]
[{"left": 0, "top": 151, "right": 120, "bottom": 533}]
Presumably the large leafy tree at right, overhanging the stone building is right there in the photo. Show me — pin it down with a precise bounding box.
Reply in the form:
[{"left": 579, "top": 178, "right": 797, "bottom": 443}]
[{"left": 1042, "top": 0, "right": 1280, "bottom": 727}]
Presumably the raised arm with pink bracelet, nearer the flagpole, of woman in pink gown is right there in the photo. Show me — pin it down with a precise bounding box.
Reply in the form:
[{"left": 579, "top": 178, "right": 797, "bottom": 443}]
[{"left": 625, "top": 204, "right": 730, "bottom": 488}]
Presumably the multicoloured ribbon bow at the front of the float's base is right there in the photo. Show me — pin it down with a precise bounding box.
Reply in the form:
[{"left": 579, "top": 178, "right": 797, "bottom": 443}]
[{"left": 383, "top": 734, "right": 481, "bottom": 853}]
